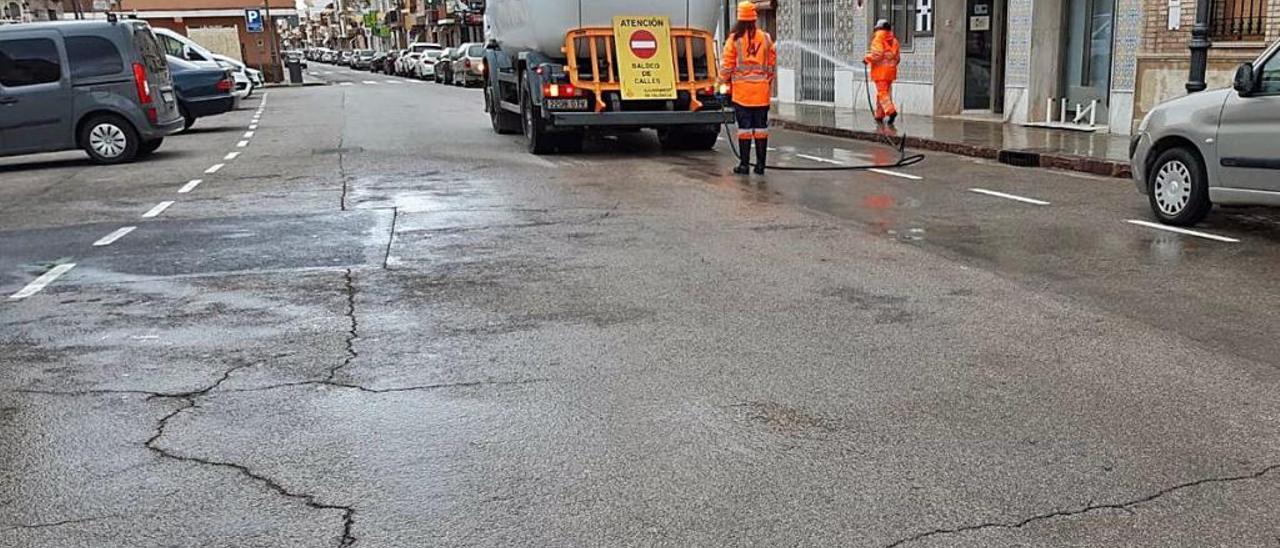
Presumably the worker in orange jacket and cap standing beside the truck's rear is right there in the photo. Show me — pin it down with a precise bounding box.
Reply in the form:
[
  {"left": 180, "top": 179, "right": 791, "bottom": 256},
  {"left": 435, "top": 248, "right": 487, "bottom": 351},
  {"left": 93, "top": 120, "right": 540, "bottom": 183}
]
[{"left": 719, "top": 1, "right": 778, "bottom": 175}]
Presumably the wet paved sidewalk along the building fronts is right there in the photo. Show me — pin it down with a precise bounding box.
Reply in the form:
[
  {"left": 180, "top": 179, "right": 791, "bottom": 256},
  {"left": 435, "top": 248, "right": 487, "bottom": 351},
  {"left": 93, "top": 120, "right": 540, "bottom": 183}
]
[{"left": 772, "top": 104, "right": 1129, "bottom": 177}]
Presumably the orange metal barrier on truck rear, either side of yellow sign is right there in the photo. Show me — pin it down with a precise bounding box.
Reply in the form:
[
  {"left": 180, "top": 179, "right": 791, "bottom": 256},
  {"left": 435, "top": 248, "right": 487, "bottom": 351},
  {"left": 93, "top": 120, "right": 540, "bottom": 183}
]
[{"left": 561, "top": 27, "right": 719, "bottom": 113}]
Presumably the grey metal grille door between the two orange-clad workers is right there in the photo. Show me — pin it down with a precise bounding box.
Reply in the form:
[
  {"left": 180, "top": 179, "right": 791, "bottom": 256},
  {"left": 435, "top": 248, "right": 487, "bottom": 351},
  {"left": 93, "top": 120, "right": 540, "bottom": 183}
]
[{"left": 800, "top": 0, "right": 836, "bottom": 102}]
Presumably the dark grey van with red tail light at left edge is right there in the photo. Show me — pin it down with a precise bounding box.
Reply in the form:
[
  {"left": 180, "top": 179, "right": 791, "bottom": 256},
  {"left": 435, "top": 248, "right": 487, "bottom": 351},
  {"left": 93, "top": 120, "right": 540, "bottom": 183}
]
[{"left": 0, "top": 17, "right": 182, "bottom": 164}]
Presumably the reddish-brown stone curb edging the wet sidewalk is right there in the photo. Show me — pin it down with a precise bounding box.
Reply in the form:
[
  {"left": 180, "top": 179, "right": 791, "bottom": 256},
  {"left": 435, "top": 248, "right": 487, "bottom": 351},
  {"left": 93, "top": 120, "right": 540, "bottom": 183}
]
[{"left": 774, "top": 118, "right": 1133, "bottom": 178}]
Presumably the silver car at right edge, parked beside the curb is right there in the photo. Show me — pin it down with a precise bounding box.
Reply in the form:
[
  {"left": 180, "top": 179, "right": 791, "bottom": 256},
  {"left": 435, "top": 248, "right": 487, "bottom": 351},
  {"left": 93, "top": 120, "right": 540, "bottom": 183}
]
[{"left": 1129, "top": 42, "right": 1280, "bottom": 225}]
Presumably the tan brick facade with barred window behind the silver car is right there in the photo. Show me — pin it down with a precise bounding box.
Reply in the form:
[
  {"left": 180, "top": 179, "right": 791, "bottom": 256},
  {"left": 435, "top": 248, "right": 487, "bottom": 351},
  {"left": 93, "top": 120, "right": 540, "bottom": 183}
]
[{"left": 1134, "top": 0, "right": 1280, "bottom": 119}]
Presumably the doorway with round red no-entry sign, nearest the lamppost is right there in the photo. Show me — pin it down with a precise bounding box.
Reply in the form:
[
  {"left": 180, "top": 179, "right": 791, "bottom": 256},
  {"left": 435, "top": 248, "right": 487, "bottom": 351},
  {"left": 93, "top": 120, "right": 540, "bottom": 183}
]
[{"left": 1061, "top": 0, "right": 1115, "bottom": 120}]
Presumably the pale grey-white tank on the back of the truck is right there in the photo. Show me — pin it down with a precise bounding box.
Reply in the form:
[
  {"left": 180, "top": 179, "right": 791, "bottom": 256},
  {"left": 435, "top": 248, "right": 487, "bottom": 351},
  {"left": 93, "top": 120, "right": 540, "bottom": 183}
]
[{"left": 484, "top": 0, "right": 723, "bottom": 56}]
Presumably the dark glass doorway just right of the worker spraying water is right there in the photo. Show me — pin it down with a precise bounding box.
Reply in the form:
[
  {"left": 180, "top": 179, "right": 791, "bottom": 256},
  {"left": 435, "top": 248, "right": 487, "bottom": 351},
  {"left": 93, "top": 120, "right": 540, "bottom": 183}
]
[{"left": 964, "top": 0, "right": 1006, "bottom": 113}]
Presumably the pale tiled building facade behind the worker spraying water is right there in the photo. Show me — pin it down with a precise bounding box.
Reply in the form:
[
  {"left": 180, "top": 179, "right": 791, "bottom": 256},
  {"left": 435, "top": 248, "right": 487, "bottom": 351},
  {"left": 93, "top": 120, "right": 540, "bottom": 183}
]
[{"left": 777, "top": 0, "right": 1144, "bottom": 133}]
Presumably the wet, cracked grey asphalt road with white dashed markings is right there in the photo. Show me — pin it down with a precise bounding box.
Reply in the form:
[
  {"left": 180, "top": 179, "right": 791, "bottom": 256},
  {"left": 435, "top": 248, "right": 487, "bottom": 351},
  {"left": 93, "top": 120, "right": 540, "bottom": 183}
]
[{"left": 0, "top": 65, "right": 1280, "bottom": 548}]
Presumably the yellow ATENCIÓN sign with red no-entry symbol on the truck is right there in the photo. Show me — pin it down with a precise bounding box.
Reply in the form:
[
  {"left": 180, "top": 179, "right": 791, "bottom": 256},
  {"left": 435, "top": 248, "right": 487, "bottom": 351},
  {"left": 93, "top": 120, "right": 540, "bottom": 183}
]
[{"left": 613, "top": 15, "right": 676, "bottom": 100}]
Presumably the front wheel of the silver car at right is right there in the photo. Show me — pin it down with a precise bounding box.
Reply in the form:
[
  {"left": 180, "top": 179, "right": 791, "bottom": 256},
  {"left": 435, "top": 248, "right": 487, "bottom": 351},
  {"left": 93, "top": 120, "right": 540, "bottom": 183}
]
[{"left": 1147, "top": 147, "right": 1213, "bottom": 227}]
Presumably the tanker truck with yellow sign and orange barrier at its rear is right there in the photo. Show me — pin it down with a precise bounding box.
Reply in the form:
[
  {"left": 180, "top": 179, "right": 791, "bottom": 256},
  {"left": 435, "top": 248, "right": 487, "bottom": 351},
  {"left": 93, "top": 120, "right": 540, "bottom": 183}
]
[{"left": 483, "top": 0, "right": 732, "bottom": 154}]
